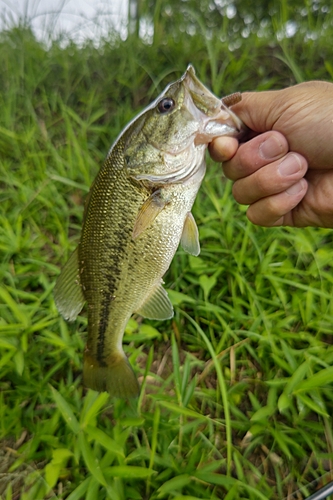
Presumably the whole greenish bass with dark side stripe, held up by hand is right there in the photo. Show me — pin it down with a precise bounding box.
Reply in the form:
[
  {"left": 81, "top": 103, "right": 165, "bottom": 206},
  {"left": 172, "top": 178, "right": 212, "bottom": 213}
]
[{"left": 54, "top": 65, "right": 244, "bottom": 398}]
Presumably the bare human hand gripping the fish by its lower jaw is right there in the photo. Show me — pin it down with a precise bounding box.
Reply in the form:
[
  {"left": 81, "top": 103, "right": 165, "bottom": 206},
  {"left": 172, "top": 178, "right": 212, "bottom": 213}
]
[{"left": 209, "top": 81, "right": 333, "bottom": 228}]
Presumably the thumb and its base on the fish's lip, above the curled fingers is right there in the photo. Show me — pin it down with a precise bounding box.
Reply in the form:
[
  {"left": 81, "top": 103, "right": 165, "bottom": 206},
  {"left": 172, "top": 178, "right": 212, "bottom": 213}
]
[{"left": 227, "top": 81, "right": 333, "bottom": 168}]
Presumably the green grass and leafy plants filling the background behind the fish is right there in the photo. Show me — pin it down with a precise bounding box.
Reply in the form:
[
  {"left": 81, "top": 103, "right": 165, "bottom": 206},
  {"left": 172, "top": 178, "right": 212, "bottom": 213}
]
[{"left": 0, "top": 2, "right": 333, "bottom": 500}]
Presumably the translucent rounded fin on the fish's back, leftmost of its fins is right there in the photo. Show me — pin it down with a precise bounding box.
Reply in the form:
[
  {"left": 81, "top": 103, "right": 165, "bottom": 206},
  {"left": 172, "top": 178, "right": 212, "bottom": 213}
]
[{"left": 53, "top": 248, "right": 85, "bottom": 321}]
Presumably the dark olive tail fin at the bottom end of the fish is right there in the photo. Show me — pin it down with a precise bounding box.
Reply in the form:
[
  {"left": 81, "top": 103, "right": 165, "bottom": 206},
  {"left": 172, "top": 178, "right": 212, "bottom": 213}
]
[{"left": 83, "top": 352, "right": 140, "bottom": 398}]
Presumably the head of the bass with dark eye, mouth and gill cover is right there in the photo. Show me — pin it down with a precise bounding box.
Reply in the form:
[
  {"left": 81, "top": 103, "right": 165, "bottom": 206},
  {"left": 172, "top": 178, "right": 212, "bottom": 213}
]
[{"left": 122, "top": 65, "right": 243, "bottom": 184}]
